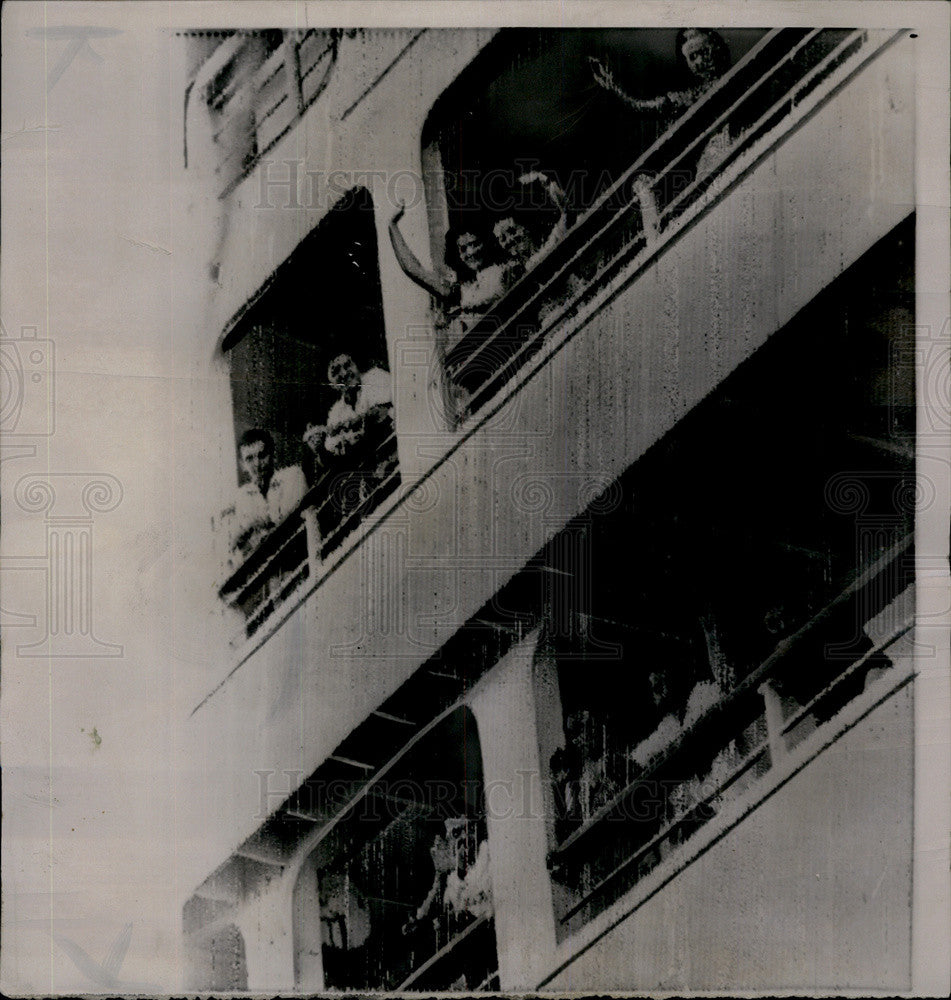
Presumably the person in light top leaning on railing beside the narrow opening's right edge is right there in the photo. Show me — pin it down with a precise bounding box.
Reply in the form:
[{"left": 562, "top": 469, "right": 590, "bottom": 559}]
[{"left": 320, "top": 354, "right": 396, "bottom": 505}]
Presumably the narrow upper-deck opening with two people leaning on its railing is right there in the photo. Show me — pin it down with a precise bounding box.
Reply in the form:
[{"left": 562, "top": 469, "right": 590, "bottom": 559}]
[{"left": 217, "top": 188, "right": 399, "bottom": 631}]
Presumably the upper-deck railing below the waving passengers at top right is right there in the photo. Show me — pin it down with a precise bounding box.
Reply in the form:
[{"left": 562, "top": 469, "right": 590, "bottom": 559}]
[{"left": 446, "top": 29, "right": 901, "bottom": 416}]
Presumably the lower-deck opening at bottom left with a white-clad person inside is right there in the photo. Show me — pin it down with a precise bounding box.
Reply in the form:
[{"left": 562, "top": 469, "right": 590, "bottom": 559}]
[{"left": 296, "top": 708, "right": 497, "bottom": 991}]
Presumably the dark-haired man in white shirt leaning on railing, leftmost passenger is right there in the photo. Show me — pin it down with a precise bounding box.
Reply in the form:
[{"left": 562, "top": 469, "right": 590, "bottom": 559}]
[{"left": 227, "top": 428, "right": 307, "bottom": 568}]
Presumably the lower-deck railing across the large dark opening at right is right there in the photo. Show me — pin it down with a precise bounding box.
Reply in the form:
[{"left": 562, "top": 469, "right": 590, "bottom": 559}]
[{"left": 548, "top": 536, "right": 914, "bottom": 928}]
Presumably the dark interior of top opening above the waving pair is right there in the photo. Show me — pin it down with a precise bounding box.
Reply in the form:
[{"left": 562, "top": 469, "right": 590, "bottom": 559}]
[{"left": 423, "top": 28, "right": 766, "bottom": 229}]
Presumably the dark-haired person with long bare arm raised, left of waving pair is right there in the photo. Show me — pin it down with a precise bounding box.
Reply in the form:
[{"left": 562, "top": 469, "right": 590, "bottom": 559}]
[{"left": 390, "top": 202, "right": 506, "bottom": 349}]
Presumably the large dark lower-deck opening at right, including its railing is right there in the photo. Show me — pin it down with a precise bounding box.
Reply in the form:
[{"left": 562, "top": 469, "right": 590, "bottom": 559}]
[{"left": 537, "top": 222, "right": 915, "bottom": 935}]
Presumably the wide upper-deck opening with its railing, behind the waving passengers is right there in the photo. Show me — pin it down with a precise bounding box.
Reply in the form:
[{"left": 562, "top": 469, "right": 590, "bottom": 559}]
[{"left": 422, "top": 29, "right": 872, "bottom": 426}]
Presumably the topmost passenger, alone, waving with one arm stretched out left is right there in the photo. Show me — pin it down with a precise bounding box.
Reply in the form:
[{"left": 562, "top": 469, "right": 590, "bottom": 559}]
[{"left": 588, "top": 28, "right": 731, "bottom": 177}]
